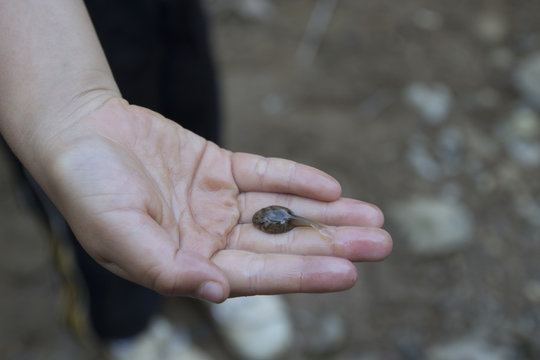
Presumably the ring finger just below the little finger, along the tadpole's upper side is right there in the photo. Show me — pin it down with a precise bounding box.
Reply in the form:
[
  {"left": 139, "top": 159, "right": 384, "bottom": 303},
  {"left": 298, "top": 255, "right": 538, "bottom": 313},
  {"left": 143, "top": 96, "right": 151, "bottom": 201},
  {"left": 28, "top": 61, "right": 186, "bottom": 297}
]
[{"left": 238, "top": 193, "right": 384, "bottom": 227}]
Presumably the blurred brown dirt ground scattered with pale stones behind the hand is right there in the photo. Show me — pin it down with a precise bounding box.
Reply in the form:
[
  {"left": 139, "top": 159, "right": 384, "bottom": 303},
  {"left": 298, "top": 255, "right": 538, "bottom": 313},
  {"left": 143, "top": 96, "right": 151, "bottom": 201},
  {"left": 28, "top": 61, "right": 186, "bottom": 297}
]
[{"left": 0, "top": 0, "right": 540, "bottom": 360}]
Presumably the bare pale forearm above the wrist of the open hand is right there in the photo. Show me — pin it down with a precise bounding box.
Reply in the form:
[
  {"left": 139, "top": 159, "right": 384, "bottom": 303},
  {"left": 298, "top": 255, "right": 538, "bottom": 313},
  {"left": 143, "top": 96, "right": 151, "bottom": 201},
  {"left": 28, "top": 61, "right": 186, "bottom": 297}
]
[{"left": 0, "top": 0, "right": 119, "bottom": 181}]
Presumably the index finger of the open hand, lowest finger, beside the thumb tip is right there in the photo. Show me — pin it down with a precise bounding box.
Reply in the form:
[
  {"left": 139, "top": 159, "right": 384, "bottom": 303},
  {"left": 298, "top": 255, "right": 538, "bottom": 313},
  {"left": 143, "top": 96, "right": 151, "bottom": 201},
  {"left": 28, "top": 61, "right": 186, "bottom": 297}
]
[{"left": 212, "top": 250, "right": 357, "bottom": 296}]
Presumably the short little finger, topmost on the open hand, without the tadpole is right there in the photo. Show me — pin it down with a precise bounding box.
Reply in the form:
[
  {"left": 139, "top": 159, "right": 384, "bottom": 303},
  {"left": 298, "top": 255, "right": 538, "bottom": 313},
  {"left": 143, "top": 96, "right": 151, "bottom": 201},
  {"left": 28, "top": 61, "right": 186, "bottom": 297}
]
[{"left": 232, "top": 153, "right": 341, "bottom": 201}]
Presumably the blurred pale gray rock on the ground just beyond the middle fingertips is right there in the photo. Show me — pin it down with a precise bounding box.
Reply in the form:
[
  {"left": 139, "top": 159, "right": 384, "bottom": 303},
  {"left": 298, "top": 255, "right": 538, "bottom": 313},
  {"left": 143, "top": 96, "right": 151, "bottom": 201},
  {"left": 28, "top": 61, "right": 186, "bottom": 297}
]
[{"left": 389, "top": 198, "right": 473, "bottom": 256}]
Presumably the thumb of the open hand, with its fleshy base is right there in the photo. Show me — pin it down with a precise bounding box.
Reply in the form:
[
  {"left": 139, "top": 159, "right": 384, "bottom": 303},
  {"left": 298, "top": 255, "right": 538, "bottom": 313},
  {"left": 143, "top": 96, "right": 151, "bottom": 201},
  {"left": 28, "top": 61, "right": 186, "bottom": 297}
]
[{"left": 73, "top": 213, "right": 230, "bottom": 303}]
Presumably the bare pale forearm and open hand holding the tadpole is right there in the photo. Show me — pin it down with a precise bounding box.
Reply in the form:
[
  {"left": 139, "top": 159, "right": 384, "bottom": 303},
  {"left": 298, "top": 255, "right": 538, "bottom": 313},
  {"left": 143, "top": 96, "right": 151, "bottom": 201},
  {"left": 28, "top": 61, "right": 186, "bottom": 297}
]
[{"left": 0, "top": 0, "right": 392, "bottom": 302}]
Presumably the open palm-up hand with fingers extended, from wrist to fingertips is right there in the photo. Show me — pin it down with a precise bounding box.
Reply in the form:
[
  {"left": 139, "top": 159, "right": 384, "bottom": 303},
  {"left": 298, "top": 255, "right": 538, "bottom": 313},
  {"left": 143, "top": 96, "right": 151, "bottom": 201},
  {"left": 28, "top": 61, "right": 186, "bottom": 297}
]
[{"left": 40, "top": 98, "right": 391, "bottom": 302}]
